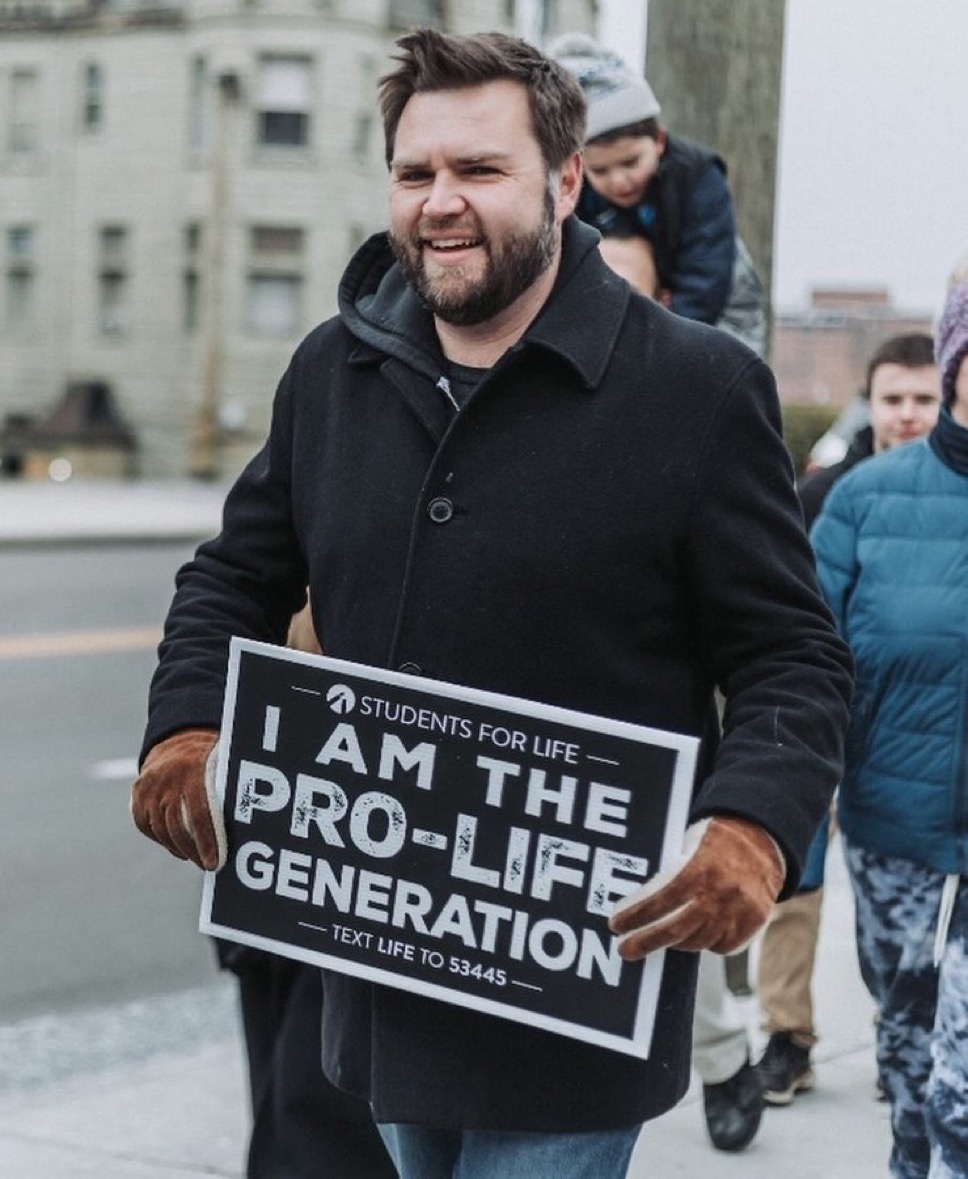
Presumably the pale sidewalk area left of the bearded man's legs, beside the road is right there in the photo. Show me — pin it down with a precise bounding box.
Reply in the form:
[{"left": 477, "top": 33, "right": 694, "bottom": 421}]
[{"left": 0, "top": 976, "right": 248, "bottom": 1179}]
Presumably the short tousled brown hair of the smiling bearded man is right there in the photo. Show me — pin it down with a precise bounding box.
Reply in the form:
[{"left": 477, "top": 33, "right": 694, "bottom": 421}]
[{"left": 378, "top": 28, "right": 585, "bottom": 171}]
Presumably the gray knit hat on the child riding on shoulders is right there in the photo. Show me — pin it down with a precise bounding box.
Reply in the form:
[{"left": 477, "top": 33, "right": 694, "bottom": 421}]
[{"left": 548, "top": 33, "right": 661, "bottom": 139}]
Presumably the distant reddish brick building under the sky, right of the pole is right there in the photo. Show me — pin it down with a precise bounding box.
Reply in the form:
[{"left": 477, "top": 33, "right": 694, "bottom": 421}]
[{"left": 771, "top": 288, "right": 934, "bottom": 408}]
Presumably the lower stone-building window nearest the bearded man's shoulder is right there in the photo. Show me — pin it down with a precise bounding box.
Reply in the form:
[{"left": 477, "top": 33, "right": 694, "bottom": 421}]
[{"left": 245, "top": 225, "right": 303, "bottom": 340}]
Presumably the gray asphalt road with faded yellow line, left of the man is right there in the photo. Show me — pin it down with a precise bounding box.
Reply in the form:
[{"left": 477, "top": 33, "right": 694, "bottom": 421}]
[{"left": 0, "top": 545, "right": 216, "bottom": 1025}]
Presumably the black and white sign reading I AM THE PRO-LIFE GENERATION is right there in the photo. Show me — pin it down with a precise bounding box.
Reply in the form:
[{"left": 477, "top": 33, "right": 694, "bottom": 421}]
[{"left": 200, "top": 639, "right": 698, "bottom": 1056}]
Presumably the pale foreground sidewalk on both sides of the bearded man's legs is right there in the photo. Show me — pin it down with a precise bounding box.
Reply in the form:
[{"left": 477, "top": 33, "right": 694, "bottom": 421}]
[{"left": 0, "top": 843, "right": 890, "bottom": 1179}]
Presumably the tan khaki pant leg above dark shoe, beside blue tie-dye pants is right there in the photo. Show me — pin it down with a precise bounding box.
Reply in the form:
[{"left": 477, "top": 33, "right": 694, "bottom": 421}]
[{"left": 759, "top": 888, "right": 823, "bottom": 1048}]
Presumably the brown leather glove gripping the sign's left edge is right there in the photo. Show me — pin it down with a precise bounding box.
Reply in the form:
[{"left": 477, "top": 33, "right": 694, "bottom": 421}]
[{"left": 131, "top": 729, "right": 228, "bottom": 871}]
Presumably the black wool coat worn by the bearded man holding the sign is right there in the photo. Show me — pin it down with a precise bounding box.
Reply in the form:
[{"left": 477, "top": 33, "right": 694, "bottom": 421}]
[{"left": 145, "top": 218, "right": 850, "bottom": 1131}]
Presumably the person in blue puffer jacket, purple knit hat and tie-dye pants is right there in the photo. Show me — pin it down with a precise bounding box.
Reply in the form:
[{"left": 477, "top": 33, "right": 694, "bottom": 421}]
[{"left": 812, "top": 282, "right": 968, "bottom": 1179}]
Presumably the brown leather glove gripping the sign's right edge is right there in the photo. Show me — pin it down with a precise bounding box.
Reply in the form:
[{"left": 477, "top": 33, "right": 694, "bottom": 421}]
[{"left": 608, "top": 815, "right": 786, "bottom": 962}]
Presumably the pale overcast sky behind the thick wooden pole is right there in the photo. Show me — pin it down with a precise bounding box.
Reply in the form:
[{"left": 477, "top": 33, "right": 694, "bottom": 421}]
[{"left": 601, "top": 0, "right": 968, "bottom": 315}]
